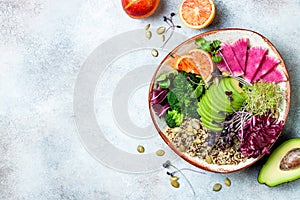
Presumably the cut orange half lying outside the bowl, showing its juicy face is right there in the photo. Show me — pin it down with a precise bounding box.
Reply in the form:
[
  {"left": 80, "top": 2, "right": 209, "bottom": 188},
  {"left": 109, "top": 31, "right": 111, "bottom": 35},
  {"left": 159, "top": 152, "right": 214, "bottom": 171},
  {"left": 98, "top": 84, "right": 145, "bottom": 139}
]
[{"left": 179, "top": 0, "right": 216, "bottom": 30}]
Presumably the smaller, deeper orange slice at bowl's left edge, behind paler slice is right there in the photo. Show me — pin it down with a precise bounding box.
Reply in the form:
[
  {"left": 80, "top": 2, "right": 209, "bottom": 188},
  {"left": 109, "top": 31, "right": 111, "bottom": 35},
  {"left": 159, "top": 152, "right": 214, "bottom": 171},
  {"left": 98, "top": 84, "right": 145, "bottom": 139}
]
[{"left": 174, "top": 55, "right": 200, "bottom": 74}]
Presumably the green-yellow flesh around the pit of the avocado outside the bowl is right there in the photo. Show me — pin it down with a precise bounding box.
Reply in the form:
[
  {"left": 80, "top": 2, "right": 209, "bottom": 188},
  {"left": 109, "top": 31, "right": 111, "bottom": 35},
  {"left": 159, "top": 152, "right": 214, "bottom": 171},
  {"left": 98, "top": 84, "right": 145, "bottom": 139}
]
[{"left": 258, "top": 138, "right": 300, "bottom": 187}]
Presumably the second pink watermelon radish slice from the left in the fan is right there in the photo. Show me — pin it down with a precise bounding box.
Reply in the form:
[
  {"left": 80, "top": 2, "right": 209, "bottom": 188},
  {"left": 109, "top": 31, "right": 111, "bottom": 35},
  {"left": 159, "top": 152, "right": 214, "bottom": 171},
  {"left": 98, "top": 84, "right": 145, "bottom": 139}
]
[{"left": 232, "top": 38, "right": 249, "bottom": 71}]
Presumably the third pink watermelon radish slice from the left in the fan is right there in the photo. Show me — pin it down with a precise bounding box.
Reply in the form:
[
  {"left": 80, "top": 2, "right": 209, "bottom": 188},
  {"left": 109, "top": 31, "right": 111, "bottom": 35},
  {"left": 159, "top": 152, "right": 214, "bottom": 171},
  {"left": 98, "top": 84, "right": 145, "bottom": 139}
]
[{"left": 244, "top": 47, "right": 267, "bottom": 83}]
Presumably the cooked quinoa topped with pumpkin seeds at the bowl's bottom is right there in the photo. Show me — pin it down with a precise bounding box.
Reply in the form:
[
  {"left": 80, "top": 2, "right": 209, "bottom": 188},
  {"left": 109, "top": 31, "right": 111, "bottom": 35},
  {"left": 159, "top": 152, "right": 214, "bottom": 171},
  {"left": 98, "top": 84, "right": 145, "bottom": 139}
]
[{"left": 166, "top": 118, "right": 247, "bottom": 165}]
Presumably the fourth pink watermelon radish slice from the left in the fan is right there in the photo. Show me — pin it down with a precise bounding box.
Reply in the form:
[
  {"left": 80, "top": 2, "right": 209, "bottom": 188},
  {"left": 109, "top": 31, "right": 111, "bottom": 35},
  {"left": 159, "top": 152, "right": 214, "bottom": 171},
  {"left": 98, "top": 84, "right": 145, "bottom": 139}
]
[{"left": 253, "top": 55, "right": 280, "bottom": 82}]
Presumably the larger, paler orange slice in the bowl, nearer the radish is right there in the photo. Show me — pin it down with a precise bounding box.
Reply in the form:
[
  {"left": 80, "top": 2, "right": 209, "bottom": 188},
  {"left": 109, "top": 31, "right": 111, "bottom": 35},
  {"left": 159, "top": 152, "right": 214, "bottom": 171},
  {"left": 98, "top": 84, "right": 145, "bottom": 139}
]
[{"left": 189, "top": 49, "right": 216, "bottom": 83}]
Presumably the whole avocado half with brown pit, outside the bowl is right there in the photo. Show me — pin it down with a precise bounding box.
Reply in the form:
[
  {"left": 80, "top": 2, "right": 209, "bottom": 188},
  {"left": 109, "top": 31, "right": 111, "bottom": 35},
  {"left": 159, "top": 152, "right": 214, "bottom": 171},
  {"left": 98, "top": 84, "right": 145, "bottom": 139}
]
[{"left": 258, "top": 138, "right": 300, "bottom": 187}]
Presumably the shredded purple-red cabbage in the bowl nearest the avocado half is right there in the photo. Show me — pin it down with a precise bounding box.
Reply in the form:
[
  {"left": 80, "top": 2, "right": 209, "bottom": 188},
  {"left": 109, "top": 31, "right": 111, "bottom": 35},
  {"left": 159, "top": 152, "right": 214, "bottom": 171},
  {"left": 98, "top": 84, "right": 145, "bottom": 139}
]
[{"left": 238, "top": 115, "right": 283, "bottom": 158}]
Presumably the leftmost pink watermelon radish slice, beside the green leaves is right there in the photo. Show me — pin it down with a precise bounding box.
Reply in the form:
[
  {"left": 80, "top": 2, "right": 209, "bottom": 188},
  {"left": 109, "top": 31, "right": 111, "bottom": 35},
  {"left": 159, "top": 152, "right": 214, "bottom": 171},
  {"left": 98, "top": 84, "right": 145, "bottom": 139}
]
[{"left": 220, "top": 43, "right": 244, "bottom": 76}]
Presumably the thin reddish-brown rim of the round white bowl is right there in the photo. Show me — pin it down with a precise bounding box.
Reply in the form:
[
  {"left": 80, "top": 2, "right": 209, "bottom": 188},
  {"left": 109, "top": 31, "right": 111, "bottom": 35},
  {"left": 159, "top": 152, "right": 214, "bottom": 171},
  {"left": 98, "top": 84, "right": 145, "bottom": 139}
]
[{"left": 148, "top": 28, "right": 291, "bottom": 173}]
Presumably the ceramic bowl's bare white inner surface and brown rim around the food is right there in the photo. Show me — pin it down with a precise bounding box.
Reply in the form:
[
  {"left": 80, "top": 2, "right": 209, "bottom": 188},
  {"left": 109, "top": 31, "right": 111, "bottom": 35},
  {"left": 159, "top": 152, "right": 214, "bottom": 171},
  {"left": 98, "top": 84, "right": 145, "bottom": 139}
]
[{"left": 148, "top": 28, "right": 290, "bottom": 173}]
